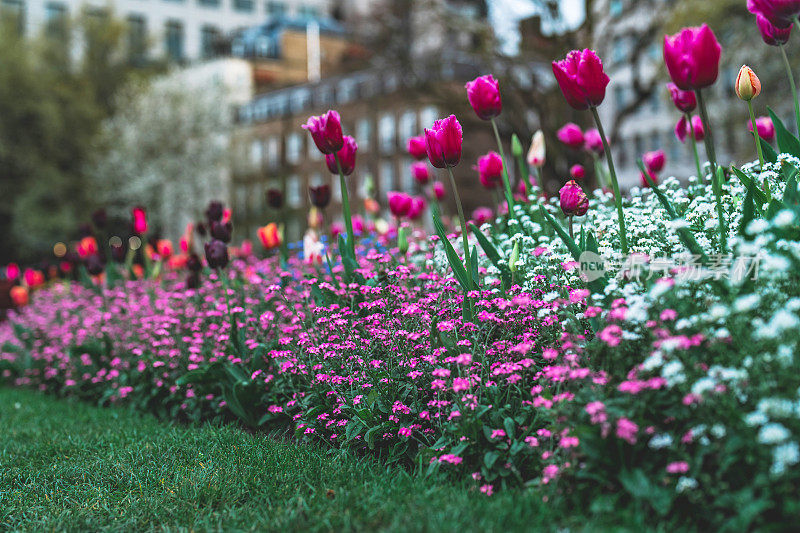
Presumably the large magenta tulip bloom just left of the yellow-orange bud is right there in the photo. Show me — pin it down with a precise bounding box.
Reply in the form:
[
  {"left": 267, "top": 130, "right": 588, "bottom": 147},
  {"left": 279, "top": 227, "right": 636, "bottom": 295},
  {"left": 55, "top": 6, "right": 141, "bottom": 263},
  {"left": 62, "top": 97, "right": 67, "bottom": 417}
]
[{"left": 664, "top": 24, "right": 722, "bottom": 91}]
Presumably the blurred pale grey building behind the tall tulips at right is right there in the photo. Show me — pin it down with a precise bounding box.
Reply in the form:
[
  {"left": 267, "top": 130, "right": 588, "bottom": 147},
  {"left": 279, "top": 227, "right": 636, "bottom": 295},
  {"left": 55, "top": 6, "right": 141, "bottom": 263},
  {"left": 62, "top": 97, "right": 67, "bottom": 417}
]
[{"left": 592, "top": 0, "right": 750, "bottom": 188}]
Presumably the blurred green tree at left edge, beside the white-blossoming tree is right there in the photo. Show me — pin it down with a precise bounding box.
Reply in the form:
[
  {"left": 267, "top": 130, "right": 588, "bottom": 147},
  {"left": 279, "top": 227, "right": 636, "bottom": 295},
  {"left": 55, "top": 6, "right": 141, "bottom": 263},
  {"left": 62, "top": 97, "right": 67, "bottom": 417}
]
[{"left": 0, "top": 11, "right": 155, "bottom": 263}]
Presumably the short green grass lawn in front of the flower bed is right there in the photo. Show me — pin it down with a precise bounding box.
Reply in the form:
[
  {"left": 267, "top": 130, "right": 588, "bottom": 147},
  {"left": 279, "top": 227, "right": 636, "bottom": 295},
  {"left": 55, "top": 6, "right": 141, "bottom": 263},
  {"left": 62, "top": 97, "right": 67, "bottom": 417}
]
[{"left": 0, "top": 389, "right": 656, "bottom": 531}]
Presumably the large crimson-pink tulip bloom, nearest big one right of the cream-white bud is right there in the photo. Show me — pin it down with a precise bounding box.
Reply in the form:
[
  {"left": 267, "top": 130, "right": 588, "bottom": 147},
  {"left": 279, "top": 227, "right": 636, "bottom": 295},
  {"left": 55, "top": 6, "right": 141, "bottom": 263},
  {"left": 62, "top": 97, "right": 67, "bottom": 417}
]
[{"left": 553, "top": 48, "right": 611, "bottom": 109}]
